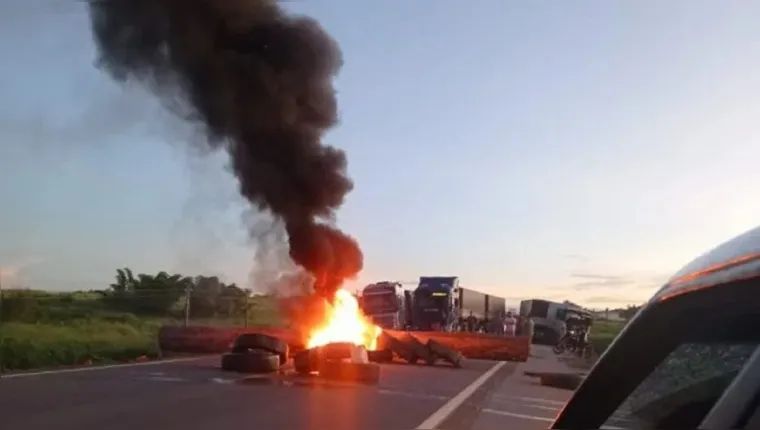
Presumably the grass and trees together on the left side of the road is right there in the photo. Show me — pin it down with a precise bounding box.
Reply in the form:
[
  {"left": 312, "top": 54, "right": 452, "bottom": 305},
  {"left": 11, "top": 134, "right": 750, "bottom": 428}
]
[{"left": 0, "top": 269, "right": 278, "bottom": 370}]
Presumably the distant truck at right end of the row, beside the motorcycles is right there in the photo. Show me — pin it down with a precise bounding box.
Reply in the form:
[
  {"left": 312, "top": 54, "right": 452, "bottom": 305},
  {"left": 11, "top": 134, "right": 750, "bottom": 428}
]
[{"left": 520, "top": 299, "right": 592, "bottom": 345}]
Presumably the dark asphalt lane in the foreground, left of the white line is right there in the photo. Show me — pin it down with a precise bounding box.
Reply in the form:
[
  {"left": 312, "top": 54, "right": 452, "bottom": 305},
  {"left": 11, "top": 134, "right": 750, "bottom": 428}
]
[{"left": 0, "top": 358, "right": 517, "bottom": 430}]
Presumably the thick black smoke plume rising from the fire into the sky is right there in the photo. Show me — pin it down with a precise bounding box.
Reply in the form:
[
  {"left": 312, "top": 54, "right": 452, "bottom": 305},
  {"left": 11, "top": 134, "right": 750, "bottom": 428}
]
[{"left": 89, "top": 0, "right": 363, "bottom": 297}]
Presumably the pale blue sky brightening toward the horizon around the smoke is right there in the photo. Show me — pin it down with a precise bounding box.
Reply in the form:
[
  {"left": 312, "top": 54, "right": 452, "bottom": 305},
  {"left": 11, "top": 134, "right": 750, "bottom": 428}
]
[{"left": 0, "top": 0, "right": 760, "bottom": 307}]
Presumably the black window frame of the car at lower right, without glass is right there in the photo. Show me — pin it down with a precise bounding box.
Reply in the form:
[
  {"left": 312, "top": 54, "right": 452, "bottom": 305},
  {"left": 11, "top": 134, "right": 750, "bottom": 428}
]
[{"left": 551, "top": 277, "right": 760, "bottom": 430}]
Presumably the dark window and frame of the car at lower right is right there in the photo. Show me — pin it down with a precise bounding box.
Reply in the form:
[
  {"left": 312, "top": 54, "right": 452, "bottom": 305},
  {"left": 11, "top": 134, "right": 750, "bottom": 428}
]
[{"left": 552, "top": 278, "right": 760, "bottom": 430}]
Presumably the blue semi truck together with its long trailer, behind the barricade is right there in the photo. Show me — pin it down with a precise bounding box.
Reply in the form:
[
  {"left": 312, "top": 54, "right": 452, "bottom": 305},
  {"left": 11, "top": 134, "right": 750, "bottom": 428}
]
[{"left": 412, "top": 276, "right": 506, "bottom": 331}]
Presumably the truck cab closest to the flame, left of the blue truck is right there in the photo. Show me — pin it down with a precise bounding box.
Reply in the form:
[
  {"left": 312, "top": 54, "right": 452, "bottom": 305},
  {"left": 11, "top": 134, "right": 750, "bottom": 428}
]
[{"left": 359, "top": 281, "right": 412, "bottom": 330}]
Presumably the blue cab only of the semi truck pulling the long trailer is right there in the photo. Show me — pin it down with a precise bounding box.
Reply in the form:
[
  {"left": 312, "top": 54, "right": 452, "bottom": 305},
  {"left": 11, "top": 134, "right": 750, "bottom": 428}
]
[{"left": 413, "top": 276, "right": 460, "bottom": 331}]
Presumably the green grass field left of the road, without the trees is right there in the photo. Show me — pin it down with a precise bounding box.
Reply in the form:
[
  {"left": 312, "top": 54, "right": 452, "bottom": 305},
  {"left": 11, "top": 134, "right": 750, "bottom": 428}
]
[{"left": 0, "top": 291, "right": 278, "bottom": 370}]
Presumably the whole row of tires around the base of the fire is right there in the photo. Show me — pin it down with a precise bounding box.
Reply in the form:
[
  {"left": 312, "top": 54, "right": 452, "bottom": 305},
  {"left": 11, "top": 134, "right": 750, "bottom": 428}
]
[{"left": 221, "top": 333, "right": 464, "bottom": 384}]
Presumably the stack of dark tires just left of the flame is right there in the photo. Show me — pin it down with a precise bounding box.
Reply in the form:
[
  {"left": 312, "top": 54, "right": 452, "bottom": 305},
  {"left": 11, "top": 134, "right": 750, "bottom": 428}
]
[{"left": 222, "top": 333, "right": 288, "bottom": 373}]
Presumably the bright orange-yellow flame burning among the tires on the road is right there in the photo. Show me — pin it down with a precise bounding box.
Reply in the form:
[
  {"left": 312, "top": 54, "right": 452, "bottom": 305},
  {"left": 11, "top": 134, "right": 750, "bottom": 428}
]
[{"left": 306, "top": 289, "right": 382, "bottom": 351}]
